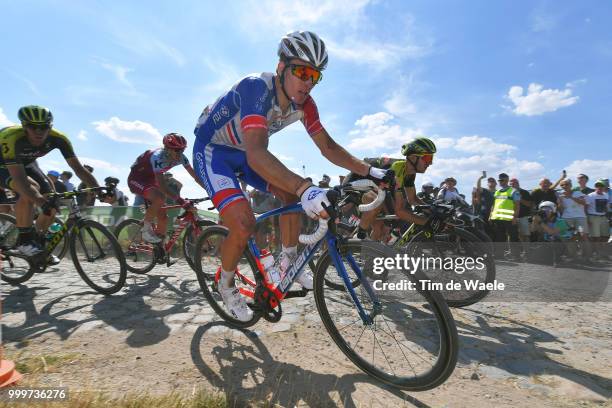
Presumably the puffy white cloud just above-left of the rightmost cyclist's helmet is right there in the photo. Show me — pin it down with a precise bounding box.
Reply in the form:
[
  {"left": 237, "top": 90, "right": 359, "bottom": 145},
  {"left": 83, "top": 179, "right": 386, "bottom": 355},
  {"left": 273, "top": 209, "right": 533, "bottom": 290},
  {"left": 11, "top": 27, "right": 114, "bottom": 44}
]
[{"left": 348, "top": 112, "right": 422, "bottom": 150}]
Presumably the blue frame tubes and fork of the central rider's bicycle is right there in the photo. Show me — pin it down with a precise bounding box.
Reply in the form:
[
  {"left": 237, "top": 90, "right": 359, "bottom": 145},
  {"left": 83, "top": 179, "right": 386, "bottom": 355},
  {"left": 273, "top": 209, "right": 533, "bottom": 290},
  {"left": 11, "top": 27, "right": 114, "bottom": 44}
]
[{"left": 248, "top": 203, "right": 381, "bottom": 325}]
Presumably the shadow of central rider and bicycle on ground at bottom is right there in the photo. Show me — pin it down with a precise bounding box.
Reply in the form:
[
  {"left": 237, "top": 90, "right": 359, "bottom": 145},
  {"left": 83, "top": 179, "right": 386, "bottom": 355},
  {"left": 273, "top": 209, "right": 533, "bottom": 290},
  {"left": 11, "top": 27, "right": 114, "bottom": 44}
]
[{"left": 191, "top": 322, "right": 429, "bottom": 408}]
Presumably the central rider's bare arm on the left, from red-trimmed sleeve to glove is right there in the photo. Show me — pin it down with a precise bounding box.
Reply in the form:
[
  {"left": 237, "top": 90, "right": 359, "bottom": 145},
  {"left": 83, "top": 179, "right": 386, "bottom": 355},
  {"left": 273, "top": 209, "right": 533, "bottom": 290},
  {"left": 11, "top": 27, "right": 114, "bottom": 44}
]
[{"left": 244, "top": 128, "right": 310, "bottom": 196}]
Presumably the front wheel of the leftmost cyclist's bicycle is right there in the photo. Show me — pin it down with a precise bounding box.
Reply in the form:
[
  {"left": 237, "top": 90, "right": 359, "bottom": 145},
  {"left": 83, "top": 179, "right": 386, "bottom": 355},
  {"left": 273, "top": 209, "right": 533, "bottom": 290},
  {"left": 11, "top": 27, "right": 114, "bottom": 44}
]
[{"left": 70, "top": 220, "right": 127, "bottom": 295}]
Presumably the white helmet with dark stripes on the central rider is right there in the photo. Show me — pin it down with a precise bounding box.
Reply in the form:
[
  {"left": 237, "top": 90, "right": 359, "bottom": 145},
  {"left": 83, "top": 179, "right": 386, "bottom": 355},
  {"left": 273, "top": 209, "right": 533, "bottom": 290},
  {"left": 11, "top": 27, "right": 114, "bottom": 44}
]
[{"left": 278, "top": 31, "right": 327, "bottom": 71}]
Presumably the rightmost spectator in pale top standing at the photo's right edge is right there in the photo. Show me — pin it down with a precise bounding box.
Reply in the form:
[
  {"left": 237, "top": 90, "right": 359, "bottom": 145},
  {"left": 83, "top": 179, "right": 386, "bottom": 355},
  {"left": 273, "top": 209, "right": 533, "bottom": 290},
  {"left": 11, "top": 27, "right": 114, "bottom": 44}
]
[{"left": 586, "top": 180, "right": 611, "bottom": 259}]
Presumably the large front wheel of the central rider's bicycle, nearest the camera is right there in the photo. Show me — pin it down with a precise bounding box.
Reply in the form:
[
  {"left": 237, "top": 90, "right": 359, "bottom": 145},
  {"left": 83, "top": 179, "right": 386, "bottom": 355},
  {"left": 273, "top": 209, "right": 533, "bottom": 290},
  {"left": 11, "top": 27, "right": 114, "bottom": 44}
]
[{"left": 314, "top": 240, "right": 458, "bottom": 391}]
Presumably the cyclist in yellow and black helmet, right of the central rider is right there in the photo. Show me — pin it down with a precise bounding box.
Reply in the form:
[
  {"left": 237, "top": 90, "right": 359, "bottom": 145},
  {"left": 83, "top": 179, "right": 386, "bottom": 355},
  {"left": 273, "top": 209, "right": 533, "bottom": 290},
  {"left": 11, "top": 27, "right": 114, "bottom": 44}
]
[{"left": 358, "top": 137, "right": 436, "bottom": 241}]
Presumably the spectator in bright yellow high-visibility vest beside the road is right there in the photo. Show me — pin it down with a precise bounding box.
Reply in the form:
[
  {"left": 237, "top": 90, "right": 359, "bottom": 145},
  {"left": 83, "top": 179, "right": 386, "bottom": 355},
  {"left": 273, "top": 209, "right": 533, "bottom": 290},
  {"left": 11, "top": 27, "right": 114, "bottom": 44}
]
[{"left": 489, "top": 173, "right": 521, "bottom": 260}]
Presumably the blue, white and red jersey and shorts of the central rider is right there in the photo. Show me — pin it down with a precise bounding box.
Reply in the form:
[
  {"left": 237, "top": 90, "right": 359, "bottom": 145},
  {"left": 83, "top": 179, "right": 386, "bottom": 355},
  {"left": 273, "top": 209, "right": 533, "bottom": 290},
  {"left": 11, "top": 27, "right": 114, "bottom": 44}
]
[{"left": 193, "top": 72, "right": 324, "bottom": 214}]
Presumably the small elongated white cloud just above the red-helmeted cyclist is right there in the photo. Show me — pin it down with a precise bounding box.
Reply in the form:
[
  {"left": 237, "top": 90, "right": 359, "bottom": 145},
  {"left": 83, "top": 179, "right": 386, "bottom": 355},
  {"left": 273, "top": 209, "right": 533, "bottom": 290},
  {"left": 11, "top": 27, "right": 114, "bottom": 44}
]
[{"left": 93, "top": 116, "right": 162, "bottom": 145}]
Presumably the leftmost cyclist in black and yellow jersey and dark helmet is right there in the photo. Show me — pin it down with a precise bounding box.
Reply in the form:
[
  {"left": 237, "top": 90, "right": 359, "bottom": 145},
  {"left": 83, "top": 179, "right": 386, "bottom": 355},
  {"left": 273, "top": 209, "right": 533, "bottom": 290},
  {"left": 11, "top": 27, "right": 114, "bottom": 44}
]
[{"left": 0, "top": 105, "right": 98, "bottom": 256}]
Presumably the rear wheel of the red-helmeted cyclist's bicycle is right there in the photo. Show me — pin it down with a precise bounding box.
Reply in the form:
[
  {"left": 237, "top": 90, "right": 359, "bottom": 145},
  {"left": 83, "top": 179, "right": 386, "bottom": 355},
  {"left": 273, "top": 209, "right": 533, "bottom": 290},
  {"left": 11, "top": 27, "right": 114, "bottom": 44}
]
[{"left": 115, "top": 218, "right": 155, "bottom": 274}]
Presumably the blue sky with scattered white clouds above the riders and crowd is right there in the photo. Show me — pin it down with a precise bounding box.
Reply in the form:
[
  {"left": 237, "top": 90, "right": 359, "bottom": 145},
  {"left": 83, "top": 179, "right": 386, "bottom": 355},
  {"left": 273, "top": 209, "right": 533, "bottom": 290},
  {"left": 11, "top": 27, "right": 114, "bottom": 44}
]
[{"left": 0, "top": 0, "right": 612, "bottom": 203}]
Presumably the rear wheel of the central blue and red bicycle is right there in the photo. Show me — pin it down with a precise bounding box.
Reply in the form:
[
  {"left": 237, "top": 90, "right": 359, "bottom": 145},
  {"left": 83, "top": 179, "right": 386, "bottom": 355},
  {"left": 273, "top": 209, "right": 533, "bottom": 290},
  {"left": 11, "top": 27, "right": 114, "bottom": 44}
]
[{"left": 194, "top": 225, "right": 261, "bottom": 328}]
